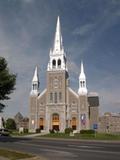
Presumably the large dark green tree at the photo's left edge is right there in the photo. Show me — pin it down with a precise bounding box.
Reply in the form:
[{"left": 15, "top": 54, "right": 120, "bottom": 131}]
[{"left": 0, "top": 57, "right": 16, "bottom": 112}]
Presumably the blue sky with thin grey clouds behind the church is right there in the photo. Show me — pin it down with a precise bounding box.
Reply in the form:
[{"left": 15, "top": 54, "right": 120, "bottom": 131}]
[{"left": 0, "top": 0, "right": 120, "bottom": 117}]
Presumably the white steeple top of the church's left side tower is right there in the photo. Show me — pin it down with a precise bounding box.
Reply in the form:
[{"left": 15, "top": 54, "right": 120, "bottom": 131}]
[{"left": 31, "top": 66, "right": 39, "bottom": 95}]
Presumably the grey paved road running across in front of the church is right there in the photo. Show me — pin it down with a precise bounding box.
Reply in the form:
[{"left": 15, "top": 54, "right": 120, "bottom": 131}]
[{"left": 0, "top": 137, "right": 120, "bottom": 160}]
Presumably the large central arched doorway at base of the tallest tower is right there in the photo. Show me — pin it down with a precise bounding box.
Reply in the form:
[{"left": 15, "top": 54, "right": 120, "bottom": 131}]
[{"left": 52, "top": 113, "right": 59, "bottom": 131}]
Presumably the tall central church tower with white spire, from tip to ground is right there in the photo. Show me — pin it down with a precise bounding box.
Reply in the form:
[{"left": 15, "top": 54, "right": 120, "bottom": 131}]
[{"left": 46, "top": 17, "right": 68, "bottom": 131}]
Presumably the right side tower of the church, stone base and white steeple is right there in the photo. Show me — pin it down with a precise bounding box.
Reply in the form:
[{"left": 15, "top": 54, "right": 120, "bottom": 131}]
[{"left": 78, "top": 62, "right": 89, "bottom": 130}]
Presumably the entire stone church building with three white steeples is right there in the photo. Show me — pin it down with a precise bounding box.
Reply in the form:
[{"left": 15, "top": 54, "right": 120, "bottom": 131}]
[{"left": 29, "top": 17, "right": 99, "bottom": 132}]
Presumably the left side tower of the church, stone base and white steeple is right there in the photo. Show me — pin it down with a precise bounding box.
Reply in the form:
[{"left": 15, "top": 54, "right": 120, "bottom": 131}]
[{"left": 29, "top": 66, "right": 39, "bottom": 132}]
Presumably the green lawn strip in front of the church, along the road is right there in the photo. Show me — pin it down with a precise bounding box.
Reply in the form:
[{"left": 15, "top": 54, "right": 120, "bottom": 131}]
[{"left": 42, "top": 133, "right": 120, "bottom": 140}]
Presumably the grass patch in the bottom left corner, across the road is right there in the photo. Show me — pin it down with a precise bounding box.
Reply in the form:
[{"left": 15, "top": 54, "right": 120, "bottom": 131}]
[{"left": 0, "top": 148, "right": 34, "bottom": 160}]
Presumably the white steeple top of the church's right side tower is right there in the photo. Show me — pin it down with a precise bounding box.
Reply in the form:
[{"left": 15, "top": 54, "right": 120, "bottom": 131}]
[{"left": 78, "top": 61, "right": 87, "bottom": 95}]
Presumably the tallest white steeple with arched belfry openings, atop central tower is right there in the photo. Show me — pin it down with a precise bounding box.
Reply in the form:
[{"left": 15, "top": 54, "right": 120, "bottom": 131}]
[{"left": 47, "top": 16, "right": 67, "bottom": 71}]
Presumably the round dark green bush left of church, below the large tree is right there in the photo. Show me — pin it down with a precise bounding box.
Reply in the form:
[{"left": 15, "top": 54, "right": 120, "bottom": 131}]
[{"left": 5, "top": 118, "right": 16, "bottom": 130}]
